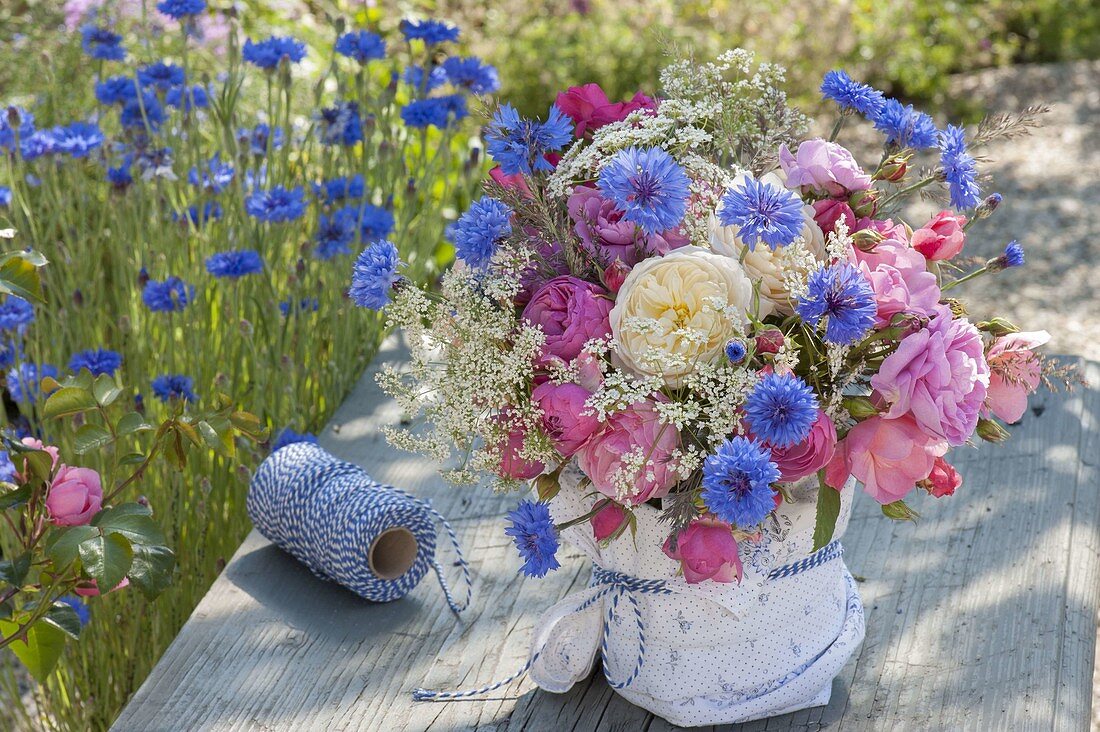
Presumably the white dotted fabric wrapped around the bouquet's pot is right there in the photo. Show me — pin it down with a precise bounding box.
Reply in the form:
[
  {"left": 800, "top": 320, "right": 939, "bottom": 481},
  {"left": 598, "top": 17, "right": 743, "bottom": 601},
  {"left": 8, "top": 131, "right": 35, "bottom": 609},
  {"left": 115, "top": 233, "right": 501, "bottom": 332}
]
[{"left": 530, "top": 470, "right": 864, "bottom": 726}]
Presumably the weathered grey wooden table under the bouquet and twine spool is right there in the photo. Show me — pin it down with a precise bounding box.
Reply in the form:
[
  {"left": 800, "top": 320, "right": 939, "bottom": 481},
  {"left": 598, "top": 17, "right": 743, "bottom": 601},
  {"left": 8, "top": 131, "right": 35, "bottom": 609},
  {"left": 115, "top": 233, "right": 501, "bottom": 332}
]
[{"left": 114, "top": 347, "right": 1100, "bottom": 732}]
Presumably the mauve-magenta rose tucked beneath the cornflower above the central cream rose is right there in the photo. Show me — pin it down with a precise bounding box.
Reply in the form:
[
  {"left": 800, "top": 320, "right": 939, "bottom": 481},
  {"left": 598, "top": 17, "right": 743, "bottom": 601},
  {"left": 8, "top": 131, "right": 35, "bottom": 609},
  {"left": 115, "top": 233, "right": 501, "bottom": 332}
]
[{"left": 567, "top": 186, "right": 688, "bottom": 266}]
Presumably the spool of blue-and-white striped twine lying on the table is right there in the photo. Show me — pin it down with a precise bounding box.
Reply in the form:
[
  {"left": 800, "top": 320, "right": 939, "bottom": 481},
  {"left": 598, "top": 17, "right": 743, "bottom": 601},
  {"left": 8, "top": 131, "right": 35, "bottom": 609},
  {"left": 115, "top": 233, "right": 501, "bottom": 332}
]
[{"left": 248, "top": 443, "right": 473, "bottom": 613}]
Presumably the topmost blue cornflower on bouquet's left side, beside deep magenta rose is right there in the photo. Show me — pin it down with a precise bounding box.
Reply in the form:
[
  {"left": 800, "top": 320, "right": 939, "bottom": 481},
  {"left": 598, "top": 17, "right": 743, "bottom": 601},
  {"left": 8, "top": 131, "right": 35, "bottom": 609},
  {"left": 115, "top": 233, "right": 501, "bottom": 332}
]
[{"left": 485, "top": 105, "right": 576, "bottom": 176}]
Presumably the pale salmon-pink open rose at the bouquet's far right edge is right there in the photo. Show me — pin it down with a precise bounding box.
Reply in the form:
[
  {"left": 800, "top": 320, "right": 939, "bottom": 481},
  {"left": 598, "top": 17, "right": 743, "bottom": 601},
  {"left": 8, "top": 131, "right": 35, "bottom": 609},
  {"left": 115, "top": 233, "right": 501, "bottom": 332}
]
[{"left": 983, "top": 330, "right": 1051, "bottom": 424}]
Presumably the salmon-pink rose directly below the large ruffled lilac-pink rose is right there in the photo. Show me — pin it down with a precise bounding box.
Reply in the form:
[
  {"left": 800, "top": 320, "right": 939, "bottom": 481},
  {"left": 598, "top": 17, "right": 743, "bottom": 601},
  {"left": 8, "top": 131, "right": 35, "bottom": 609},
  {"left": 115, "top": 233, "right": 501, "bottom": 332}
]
[{"left": 825, "top": 415, "right": 943, "bottom": 505}]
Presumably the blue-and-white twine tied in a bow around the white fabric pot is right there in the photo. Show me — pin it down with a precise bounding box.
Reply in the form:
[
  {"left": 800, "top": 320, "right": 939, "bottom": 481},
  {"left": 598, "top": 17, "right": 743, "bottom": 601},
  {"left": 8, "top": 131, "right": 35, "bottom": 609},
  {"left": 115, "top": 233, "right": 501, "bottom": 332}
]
[{"left": 413, "top": 539, "right": 844, "bottom": 701}]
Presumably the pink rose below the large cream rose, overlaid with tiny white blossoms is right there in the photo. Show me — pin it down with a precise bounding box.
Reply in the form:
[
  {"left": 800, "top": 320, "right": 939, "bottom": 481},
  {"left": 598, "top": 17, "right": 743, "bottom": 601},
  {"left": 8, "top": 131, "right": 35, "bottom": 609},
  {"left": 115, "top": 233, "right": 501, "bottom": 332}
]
[{"left": 576, "top": 394, "right": 680, "bottom": 505}]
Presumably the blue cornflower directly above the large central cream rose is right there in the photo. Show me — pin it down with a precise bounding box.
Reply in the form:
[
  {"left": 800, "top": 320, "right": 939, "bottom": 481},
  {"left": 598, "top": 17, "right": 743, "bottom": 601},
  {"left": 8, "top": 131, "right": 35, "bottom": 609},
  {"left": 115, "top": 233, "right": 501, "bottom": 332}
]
[{"left": 597, "top": 148, "right": 690, "bottom": 233}]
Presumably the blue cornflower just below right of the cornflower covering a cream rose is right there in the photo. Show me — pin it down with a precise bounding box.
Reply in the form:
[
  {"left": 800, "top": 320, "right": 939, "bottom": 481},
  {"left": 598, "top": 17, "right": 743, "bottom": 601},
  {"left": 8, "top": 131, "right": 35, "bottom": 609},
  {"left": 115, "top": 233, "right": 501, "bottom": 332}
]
[{"left": 796, "top": 262, "right": 878, "bottom": 346}]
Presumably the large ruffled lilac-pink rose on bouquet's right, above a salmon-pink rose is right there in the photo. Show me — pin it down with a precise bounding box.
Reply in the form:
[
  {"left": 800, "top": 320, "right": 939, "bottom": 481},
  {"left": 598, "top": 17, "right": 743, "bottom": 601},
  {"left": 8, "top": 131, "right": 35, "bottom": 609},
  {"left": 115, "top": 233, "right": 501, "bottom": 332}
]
[{"left": 871, "top": 306, "right": 989, "bottom": 446}]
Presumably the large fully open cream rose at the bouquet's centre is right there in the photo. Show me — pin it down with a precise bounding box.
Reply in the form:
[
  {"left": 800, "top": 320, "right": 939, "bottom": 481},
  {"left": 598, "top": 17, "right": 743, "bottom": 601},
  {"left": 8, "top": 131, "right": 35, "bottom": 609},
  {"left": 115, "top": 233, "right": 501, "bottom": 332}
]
[{"left": 611, "top": 247, "right": 752, "bottom": 386}]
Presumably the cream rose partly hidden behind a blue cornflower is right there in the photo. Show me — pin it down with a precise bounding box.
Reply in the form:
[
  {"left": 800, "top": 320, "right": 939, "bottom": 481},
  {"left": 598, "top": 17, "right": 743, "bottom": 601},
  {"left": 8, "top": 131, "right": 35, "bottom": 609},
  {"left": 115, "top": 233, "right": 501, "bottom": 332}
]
[{"left": 710, "top": 173, "right": 825, "bottom": 315}]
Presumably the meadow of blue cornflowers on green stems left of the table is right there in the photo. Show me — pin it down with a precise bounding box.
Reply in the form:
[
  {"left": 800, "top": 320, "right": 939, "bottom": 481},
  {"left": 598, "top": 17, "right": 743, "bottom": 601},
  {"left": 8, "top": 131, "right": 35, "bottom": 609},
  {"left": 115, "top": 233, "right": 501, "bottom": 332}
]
[{"left": 0, "top": 8, "right": 486, "bottom": 729}]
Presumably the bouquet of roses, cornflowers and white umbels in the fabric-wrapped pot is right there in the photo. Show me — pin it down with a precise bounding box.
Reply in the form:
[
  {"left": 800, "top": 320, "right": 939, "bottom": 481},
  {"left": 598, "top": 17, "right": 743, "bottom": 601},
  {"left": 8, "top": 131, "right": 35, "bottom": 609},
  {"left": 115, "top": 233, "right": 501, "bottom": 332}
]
[{"left": 351, "top": 51, "right": 1069, "bottom": 723}]
